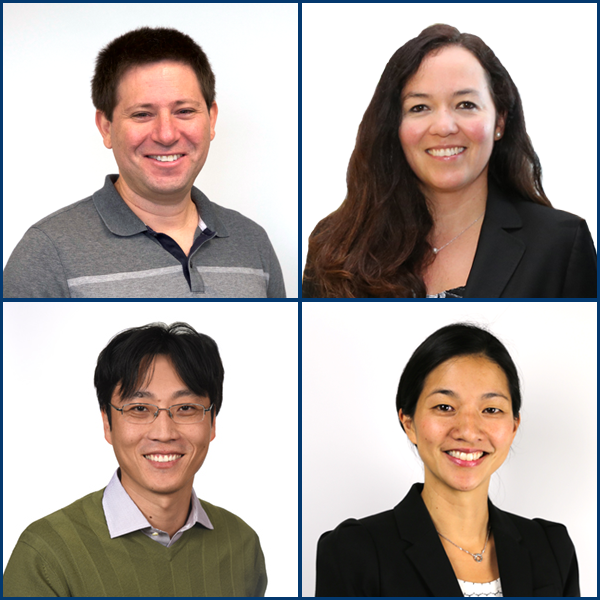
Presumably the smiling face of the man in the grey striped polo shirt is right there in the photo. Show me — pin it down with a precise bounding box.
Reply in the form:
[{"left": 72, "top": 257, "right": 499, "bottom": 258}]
[{"left": 96, "top": 61, "right": 217, "bottom": 204}]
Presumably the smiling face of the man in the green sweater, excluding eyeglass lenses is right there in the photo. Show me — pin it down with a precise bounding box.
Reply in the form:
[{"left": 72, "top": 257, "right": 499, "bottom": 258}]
[{"left": 102, "top": 356, "right": 216, "bottom": 496}]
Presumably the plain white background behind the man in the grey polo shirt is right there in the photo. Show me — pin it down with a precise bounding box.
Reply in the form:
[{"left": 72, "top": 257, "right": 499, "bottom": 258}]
[{"left": 4, "top": 3, "right": 298, "bottom": 297}]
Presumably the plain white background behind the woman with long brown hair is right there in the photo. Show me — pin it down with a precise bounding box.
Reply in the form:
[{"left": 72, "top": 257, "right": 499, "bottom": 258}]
[{"left": 302, "top": 3, "right": 597, "bottom": 272}]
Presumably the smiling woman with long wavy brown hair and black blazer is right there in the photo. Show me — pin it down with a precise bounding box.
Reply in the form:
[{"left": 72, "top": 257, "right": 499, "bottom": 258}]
[{"left": 302, "top": 25, "right": 596, "bottom": 298}]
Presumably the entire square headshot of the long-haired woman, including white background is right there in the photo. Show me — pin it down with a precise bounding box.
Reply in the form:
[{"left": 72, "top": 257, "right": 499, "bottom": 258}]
[{"left": 302, "top": 4, "right": 597, "bottom": 298}]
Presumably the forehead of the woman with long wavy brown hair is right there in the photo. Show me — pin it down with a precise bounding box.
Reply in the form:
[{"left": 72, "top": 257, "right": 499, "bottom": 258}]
[{"left": 403, "top": 46, "right": 489, "bottom": 97}]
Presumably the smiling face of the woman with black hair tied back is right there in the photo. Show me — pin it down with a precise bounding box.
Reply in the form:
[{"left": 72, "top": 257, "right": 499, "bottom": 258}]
[{"left": 400, "top": 355, "right": 519, "bottom": 492}]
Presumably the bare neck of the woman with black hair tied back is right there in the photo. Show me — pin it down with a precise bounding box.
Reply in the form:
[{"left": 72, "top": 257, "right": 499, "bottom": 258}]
[{"left": 421, "top": 470, "right": 489, "bottom": 551}]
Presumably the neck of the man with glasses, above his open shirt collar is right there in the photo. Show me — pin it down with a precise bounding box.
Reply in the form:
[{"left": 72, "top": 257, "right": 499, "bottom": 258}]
[{"left": 121, "top": 471, "right": 193, "bottom": 537}]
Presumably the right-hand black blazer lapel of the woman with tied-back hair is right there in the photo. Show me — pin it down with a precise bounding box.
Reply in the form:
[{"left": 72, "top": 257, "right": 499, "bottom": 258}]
[{"left": 488, "top": 502, "right": 533, "bottom": 597}]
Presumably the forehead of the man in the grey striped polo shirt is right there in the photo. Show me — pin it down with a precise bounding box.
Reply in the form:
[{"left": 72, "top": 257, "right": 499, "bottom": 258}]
[{"left": 117, "top": 60, "right": 203, "bottom": 102}]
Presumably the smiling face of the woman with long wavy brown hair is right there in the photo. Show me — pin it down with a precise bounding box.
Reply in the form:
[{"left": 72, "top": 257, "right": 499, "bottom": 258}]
[{"left": 399, "top": 46, "right": 503, "bottom": 195}]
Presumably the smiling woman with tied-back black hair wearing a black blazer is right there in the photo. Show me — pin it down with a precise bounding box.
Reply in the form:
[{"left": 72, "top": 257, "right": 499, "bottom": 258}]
[{"left": 316, "top": 324, "right": 580, "bottom": 597}]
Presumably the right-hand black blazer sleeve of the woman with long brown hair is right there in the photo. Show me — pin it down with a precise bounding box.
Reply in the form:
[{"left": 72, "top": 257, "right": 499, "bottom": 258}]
[{"left": 562, "top": 219, "right": 597, "bottom": 298}]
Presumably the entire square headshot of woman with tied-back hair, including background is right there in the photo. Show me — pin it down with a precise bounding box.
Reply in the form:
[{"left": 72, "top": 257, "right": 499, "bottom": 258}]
[{"left": 302, "top": 302, "right": 597, "bottom": 597}]
